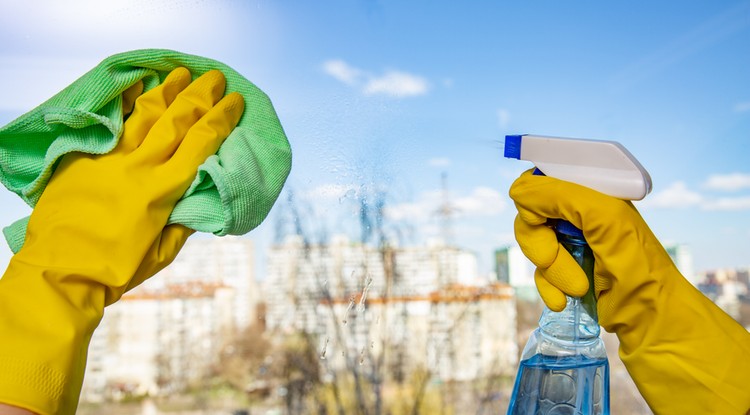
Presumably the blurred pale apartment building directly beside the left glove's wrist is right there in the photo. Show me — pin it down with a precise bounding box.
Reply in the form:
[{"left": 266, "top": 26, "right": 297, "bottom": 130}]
[{"left": 82, "top": 237, "right": 260, "bottom": 401}]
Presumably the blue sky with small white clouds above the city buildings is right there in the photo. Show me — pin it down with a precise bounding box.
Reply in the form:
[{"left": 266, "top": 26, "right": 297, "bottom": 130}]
[{"left": 0, "top": 0, "right": 750, "bottom": 278}]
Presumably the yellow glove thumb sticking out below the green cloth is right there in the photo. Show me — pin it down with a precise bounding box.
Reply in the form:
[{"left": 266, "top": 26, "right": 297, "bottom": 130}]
[{"left": 122, "top": 224, "right": 195, "bottom": 301}]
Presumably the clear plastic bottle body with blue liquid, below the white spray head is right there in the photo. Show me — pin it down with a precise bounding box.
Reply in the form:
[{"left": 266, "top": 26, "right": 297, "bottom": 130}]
[{"left": 508, "top": 216, "right": 609, "bottom": 415}]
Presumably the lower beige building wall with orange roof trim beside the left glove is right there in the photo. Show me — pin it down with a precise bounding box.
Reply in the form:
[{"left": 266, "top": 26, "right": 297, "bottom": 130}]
[{"left": 82, "top": 274, "right": 234, "bottom": 401}]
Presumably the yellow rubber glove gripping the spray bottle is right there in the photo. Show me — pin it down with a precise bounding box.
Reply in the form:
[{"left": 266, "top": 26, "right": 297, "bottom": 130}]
[{"left": 510, "top": 171, "right": 750, "bottom": 415}]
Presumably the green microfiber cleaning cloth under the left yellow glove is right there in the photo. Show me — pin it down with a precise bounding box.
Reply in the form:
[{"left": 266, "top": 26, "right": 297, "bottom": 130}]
[{"left": 0, "top": 49, "right": 291, "bottom": 253}]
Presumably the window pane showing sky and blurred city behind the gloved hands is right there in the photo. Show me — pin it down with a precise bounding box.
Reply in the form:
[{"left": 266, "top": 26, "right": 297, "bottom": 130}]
[{"left": 0, "top": 0, "right": 750, "bottom": 414}]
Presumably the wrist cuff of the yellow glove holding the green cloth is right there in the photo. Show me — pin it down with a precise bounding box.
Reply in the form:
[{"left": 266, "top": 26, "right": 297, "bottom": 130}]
[{"left": 0, "top": 257, "right": 104, "bottom": 415}]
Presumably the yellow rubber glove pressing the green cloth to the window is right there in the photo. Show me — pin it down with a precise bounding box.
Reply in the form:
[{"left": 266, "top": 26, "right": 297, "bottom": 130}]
[{"left": 0, "top": 68, "right": 244, "bottom": 415}]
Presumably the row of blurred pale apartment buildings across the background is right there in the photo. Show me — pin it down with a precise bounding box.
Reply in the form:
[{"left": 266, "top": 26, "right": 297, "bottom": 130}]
[{"left": 79, "top": 224, "right": 750, "bottom": 408}]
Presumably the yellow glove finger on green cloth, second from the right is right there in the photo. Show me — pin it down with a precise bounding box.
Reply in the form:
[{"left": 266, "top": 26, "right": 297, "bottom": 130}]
[{"left": 138, "top": 70, "right": 226, "bottom": 162}]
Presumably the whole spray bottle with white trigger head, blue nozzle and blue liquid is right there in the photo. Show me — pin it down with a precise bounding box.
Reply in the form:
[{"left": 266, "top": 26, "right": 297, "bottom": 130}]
[{"left": 505, "top": 135, "right": 651, "bottom": 415}]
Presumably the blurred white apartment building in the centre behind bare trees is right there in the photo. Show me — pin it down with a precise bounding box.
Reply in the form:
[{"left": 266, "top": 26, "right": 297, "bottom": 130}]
[{"left": 264, "top": 237, "right": 518, "bottom": 380}]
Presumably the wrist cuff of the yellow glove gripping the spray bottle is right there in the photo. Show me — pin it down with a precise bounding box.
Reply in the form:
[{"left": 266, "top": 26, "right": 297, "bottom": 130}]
[{"left": 617, "top": 275, "right": 750, "bottom": 414}]
